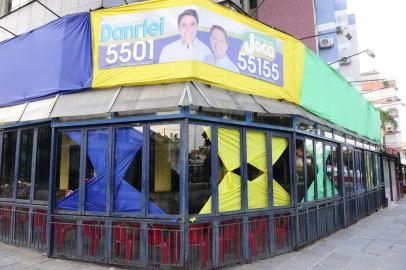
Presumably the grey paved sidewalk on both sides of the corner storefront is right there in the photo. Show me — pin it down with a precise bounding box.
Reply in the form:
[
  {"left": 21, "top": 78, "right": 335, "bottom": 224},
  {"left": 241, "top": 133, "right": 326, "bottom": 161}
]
[{"left": 0, "top": 200, "right": 406, "bottom": 270}]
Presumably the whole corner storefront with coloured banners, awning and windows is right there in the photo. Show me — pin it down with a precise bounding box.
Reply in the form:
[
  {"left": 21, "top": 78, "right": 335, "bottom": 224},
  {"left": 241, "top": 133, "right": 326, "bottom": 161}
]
[{"left": 0, "top": 0, "right": 396, "bottom": 269}]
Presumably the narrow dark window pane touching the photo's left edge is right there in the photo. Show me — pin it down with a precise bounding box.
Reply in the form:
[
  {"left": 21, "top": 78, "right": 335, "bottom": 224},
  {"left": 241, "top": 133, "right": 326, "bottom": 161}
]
[{"left": 0, "top": 131, "right": 17, "bottom": 198}]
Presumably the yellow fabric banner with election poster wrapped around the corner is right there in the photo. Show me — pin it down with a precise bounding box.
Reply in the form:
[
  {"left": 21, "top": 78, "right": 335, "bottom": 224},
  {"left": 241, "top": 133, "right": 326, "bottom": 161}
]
[{"left": 91, "top": 0, "right": 304, "bottom": 104}]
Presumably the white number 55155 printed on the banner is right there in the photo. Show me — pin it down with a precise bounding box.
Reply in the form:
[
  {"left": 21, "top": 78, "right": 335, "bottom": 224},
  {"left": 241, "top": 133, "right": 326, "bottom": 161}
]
[{"left": 238, "top": 52, "right": 279, "bottom": 81}]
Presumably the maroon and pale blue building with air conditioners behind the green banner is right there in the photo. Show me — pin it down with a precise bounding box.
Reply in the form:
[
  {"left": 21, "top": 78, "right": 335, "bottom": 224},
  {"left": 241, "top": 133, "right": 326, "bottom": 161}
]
[{"left": 254, "top": 0, "right": 360, "bottom": 85}]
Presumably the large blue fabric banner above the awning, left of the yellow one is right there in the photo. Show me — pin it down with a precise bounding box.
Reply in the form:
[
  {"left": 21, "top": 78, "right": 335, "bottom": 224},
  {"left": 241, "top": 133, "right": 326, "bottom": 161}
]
[{"left": 0, "top": 13, "right": 92, "bottom": 106}]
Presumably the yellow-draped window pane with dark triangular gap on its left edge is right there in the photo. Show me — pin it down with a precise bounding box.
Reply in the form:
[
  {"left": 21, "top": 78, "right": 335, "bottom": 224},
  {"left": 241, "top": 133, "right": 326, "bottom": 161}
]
[{"left": 247, "top": 131, "right": 269, "bottom": 209}]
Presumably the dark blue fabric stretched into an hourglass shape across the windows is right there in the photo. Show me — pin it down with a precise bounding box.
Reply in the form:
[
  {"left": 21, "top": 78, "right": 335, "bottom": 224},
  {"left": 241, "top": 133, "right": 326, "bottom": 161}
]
[{"left": 57, "top": 128, "right": 165, "bottom": 214}]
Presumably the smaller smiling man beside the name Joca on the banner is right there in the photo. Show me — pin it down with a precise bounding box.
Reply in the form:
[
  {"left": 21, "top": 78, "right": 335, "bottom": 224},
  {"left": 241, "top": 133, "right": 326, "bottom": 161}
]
[{"left": 204, "top": 25, "right": 239, "bottom": 73}]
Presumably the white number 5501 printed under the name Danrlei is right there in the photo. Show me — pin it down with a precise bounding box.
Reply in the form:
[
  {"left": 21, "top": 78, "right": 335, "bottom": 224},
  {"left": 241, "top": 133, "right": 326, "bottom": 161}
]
[{"left": 105, "top": 40, "right": 154, "bottom": 64}]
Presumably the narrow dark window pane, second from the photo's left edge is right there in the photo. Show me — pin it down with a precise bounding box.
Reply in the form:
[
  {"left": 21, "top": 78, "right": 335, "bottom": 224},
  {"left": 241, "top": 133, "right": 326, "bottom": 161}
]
[{"left": 17, "top": 128, "right": 34, "bottom": 200}]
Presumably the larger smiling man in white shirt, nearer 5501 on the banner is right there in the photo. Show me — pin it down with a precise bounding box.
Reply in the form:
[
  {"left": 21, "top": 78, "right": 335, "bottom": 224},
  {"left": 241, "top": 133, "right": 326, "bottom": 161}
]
[{"left": 159, "top": 9, "right": 210, "bottom": 63}]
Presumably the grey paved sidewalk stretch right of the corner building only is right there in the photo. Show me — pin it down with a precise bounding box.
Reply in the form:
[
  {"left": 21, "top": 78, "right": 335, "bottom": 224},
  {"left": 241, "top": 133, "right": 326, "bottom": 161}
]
[{"left": 229, "top": 199, "right": 406, "bottom": 270}]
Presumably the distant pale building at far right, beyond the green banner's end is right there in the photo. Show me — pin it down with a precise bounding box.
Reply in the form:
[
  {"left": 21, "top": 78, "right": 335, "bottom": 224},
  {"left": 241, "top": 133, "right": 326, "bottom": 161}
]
[{"left": 361, "top": 71, "right": 404, "bottom": 152}]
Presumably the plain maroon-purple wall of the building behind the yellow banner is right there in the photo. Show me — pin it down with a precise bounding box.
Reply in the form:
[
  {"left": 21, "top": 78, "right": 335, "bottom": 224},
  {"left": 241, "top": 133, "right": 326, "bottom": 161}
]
[{"left": 258, "top": 0, "right": 317, "bottom": 53}]
